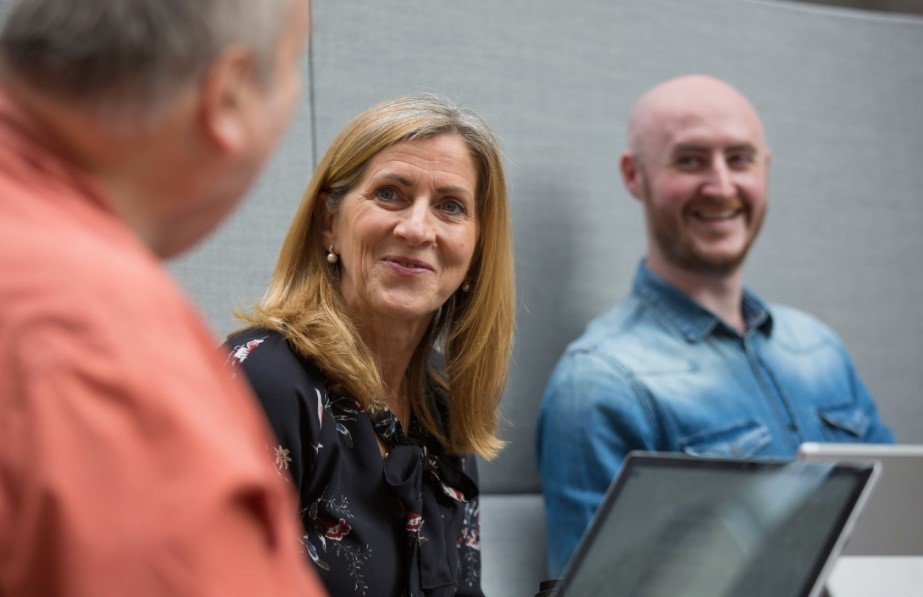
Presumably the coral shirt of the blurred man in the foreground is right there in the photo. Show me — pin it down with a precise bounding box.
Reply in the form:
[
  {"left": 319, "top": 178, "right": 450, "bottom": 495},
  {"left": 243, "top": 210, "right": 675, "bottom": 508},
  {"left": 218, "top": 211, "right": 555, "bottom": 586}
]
[{"left": 0, "top": 91, "right": 323, "bottom": 597}]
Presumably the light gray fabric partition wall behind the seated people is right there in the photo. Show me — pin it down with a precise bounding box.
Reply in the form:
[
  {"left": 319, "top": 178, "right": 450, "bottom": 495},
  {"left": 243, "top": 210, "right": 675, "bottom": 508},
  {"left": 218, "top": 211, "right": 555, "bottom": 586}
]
[{"left": 0, "top": 0, "right": 923, "bottom": 596}]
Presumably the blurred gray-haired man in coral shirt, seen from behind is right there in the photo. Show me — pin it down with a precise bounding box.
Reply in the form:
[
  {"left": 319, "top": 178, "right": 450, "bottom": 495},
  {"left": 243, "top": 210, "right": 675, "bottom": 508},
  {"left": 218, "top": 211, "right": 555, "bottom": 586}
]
[{"left": 0, "top": 0, "right": 321, "bottom": 597}]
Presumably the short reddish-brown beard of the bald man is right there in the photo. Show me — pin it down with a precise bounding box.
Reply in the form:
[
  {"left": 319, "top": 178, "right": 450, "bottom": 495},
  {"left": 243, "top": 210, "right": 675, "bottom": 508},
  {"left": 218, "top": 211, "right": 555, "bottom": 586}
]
[{"left": 641, "top": 180, "right": 766, "bottom": 278}]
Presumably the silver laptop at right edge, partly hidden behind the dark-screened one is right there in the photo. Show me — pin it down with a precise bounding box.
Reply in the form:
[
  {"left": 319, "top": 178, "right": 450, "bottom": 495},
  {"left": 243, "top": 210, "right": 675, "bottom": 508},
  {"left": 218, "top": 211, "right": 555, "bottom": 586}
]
[{"left": 798, "top": 443, "right": 923, "bottom": 556}]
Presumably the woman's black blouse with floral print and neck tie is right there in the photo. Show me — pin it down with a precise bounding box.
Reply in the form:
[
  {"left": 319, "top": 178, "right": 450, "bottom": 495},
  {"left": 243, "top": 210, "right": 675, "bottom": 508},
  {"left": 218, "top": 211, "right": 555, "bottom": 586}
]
[{"left": 228, "top": 329, "right": 483, "bottom": 597}]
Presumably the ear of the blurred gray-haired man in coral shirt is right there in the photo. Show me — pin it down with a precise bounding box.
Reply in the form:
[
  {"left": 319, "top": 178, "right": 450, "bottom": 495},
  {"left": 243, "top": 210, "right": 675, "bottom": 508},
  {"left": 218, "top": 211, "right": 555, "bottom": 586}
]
[{"left": 200, "top": 46, "right": 257, "bottom": 153}]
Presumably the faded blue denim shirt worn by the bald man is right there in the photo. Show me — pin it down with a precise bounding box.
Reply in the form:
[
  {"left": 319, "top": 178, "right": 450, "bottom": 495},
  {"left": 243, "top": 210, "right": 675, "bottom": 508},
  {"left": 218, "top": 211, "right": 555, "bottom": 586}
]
[{"left": 537, "top": 262, "right": 894, "bottom": 576}]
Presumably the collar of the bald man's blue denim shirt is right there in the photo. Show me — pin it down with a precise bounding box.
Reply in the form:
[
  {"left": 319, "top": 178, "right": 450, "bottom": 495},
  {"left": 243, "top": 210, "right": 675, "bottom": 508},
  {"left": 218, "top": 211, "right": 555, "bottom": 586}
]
[{"left": 632, "top": 260, "right": 772, "bottom": 342}]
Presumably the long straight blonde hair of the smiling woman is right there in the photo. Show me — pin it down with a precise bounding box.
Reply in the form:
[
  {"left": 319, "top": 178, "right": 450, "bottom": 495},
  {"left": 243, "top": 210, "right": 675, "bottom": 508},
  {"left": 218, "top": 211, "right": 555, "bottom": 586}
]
[{"left": 241, "top": 93, "right": 516, "bottom": 459}]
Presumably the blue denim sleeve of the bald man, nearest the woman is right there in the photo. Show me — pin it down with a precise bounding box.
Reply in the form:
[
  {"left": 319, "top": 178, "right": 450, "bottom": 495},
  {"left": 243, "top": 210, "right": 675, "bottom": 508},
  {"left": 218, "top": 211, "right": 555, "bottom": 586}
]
[{"left": 536, "top": 350, "right": 657, "bottom": 577}]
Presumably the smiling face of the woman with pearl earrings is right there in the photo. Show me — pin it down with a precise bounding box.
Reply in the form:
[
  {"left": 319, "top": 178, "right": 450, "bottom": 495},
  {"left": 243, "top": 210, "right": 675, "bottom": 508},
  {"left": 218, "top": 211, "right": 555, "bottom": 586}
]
[{"left": 324, "top": 134, "right": 478, "bottom": 326}]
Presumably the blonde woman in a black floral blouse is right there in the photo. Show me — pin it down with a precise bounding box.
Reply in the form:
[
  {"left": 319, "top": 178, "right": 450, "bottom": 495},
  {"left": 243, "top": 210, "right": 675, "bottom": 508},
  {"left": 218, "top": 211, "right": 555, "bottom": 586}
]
[{"left": 228, "top": 94, "right": 515, "bottom": 596}]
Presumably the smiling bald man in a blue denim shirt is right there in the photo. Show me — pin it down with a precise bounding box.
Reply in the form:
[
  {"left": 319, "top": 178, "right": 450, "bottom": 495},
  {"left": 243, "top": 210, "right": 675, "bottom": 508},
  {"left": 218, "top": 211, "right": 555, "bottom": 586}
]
[{"left": 537, "top": 75, "right": 894, "bottom": 575}]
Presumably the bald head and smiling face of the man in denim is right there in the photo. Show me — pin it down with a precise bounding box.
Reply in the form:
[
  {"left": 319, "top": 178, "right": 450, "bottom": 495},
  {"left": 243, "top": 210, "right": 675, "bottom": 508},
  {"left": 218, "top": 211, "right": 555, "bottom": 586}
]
[{"left": 623, "top": 78, "right": 770, "bottom": 275}]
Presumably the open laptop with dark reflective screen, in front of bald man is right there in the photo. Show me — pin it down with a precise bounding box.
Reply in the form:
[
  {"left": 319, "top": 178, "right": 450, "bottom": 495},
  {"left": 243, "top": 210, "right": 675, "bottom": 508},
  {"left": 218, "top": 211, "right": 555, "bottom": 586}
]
[{"left": 554, "top": 452, "right": 879, "bottom": 597}]
